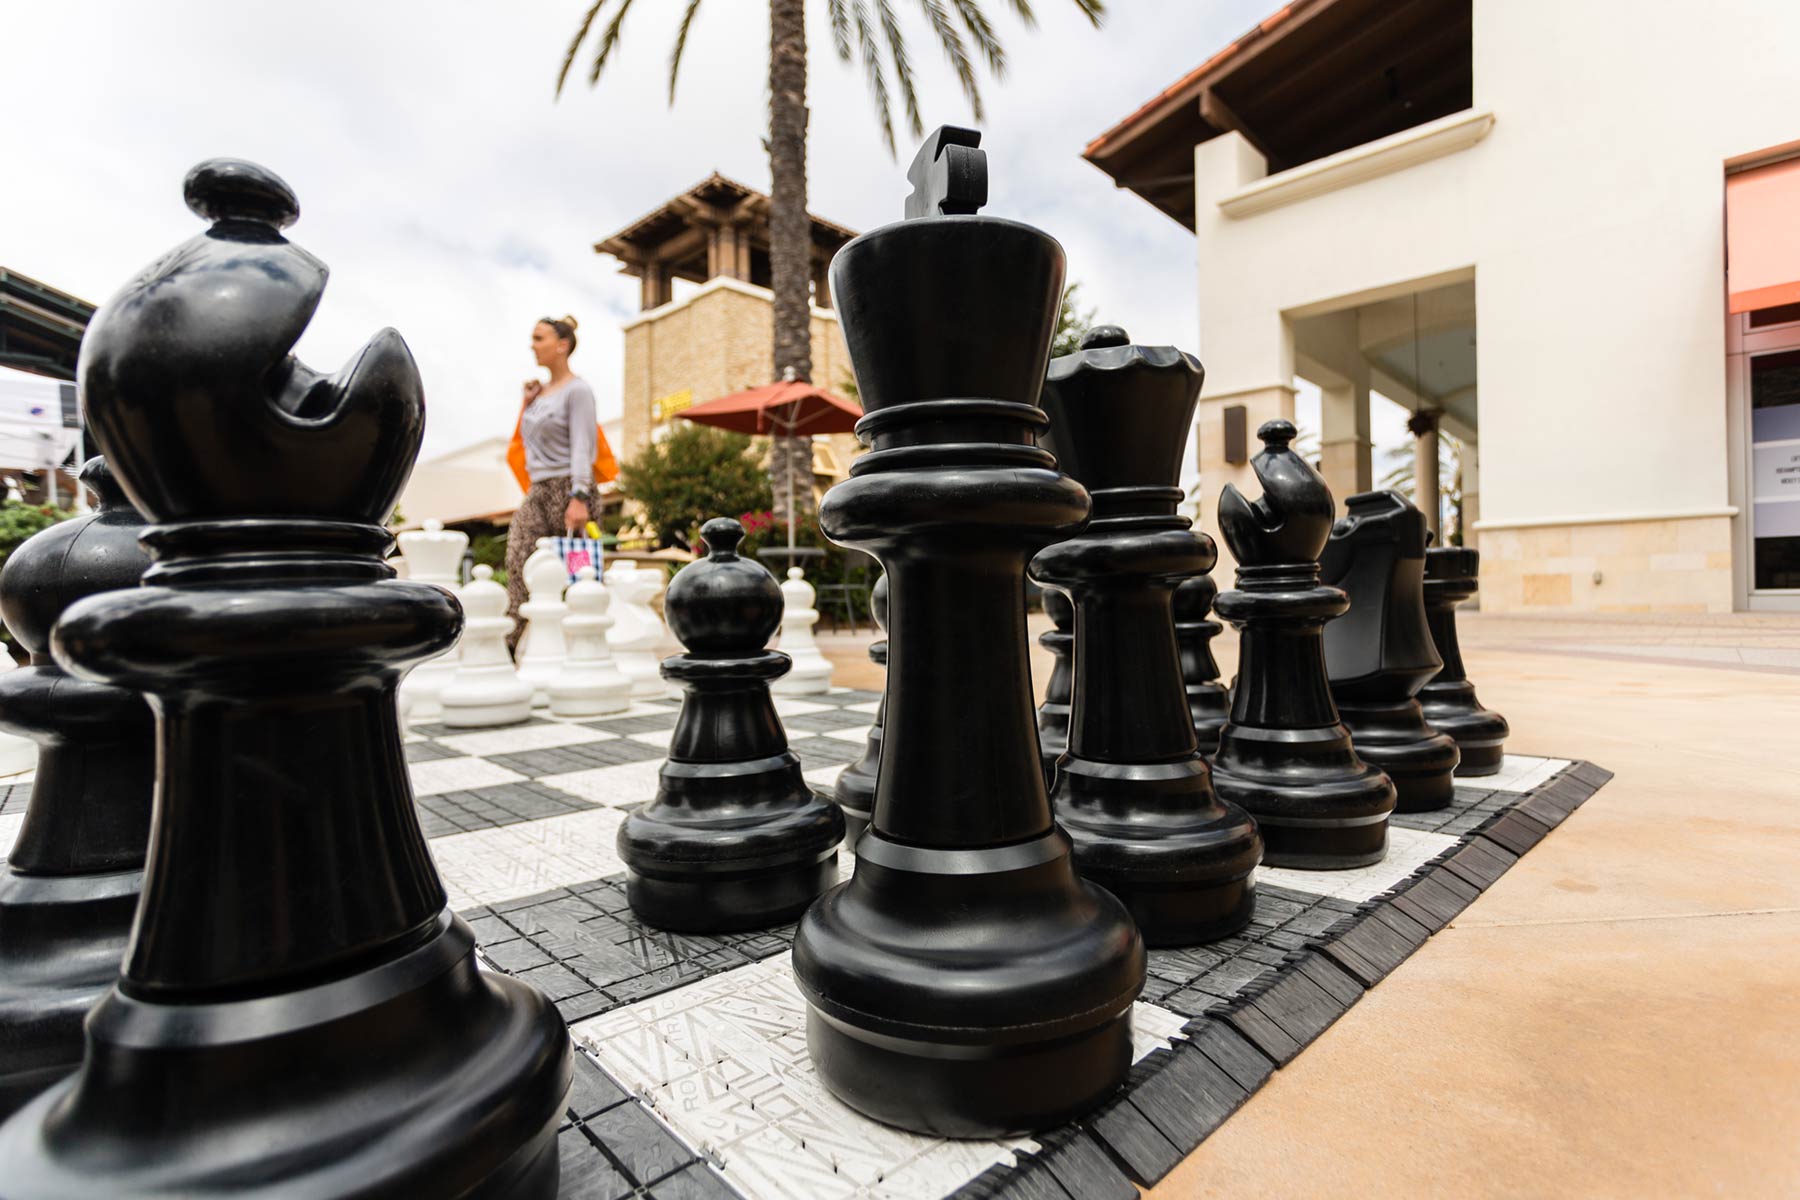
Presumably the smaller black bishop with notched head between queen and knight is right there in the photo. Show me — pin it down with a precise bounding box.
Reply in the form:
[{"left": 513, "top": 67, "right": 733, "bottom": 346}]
[{"left": 1213, "top": 421, "right": 1393, "bottom": 871}]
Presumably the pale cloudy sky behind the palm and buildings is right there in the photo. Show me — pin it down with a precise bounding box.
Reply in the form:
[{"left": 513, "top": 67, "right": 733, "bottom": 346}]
[{"left": 0, "top": 0, "right": 1404, "bottom": 459}]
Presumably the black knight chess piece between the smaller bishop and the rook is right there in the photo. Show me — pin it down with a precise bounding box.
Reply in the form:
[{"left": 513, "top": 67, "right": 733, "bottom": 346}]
[{"left": 1319, "top": 491, "right": 1458, "bottom": 813}]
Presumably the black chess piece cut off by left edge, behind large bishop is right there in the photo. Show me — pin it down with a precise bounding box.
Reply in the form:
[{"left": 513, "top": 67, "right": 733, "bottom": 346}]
[{"left": 0, "top": 459, "right": 157, "bottom": 1117}]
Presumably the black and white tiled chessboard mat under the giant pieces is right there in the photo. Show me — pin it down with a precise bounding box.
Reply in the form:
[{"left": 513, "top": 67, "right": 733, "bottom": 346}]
[{"left": 0, "top": 689, "right": 1611, "bottom": 1200}]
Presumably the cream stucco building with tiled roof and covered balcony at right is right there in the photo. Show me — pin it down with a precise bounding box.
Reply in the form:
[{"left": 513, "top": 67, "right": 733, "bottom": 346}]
[{"left": 1085, "top": 0, "right": 1800, "bottom": 612}]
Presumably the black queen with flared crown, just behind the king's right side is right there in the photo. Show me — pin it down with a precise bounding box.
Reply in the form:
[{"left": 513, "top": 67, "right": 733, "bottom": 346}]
[{"left": 1031, "top": 326, "right": 1262, "bottom": 946}]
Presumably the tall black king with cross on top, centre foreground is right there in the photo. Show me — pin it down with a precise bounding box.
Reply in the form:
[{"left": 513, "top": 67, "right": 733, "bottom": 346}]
[{"left": 794, "top": 128, "right": 1145, "bottom": 1137}]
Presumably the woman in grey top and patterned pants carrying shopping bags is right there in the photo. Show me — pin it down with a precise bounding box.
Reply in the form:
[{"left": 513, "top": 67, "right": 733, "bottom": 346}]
[{"left": 506, "top": 317, "right": 619, "bottom": 648}]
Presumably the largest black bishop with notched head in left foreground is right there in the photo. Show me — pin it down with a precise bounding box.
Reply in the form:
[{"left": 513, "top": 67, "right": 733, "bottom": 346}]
[{"left": 0, "top": 158, "right": 569, "bottom": 1200}]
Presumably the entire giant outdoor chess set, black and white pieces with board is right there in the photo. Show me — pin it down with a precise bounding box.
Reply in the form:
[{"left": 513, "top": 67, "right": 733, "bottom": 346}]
[{"left": 0, "top": 128, "right": 1607, "bottom": 1200}]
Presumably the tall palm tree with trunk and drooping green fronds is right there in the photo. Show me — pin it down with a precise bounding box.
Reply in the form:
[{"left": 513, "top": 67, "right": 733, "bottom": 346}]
[{"left": 556, "top": 0, "right": 1105, "bottom": 516}]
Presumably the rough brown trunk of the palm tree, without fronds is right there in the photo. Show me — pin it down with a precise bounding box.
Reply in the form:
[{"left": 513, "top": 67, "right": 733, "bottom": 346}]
[{"left": 769, "top": 0, "right": 812, "bottom": 520}]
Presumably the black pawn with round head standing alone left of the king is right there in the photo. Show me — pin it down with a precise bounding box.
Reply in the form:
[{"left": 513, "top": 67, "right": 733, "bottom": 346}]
[{"left": 619, "top": 516, "right": 844, "bottom": 934}]
